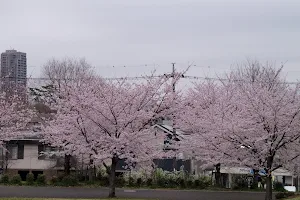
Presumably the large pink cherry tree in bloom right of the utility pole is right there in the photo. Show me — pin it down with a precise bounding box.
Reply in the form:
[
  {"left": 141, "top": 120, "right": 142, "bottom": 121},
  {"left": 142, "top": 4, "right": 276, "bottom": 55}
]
[{"left": 178, "top": 62, "right": 300, "bottom": 200}]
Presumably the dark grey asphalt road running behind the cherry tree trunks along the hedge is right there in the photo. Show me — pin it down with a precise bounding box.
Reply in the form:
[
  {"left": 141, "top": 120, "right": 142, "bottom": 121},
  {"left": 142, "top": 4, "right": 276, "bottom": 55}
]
[{"left": 0, "top": 186, "right": 270, "bottom": 200}]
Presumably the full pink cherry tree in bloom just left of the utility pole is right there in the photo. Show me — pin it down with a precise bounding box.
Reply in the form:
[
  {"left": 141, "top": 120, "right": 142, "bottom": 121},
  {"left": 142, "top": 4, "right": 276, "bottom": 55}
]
[{"left": 45, "top": 76, "right": 177, "bottom": 197}]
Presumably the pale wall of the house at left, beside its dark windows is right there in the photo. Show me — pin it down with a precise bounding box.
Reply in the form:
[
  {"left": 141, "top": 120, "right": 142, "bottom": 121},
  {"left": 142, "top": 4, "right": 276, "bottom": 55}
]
[{"left": 8, "top": 144, "right": 56, "bottom": 170}]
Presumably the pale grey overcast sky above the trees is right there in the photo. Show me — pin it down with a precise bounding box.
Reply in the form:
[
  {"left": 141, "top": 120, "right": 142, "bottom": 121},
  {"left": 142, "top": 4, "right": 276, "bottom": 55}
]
[{"left": 0, "top": 0, "right": 300, "bottom": 80}]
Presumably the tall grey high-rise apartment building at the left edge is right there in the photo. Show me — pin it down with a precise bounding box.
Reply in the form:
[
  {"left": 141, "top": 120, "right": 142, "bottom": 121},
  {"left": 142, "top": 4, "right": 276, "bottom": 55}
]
[{"left": 0, "top": 50, "right": 27, "bottom": 91}]
